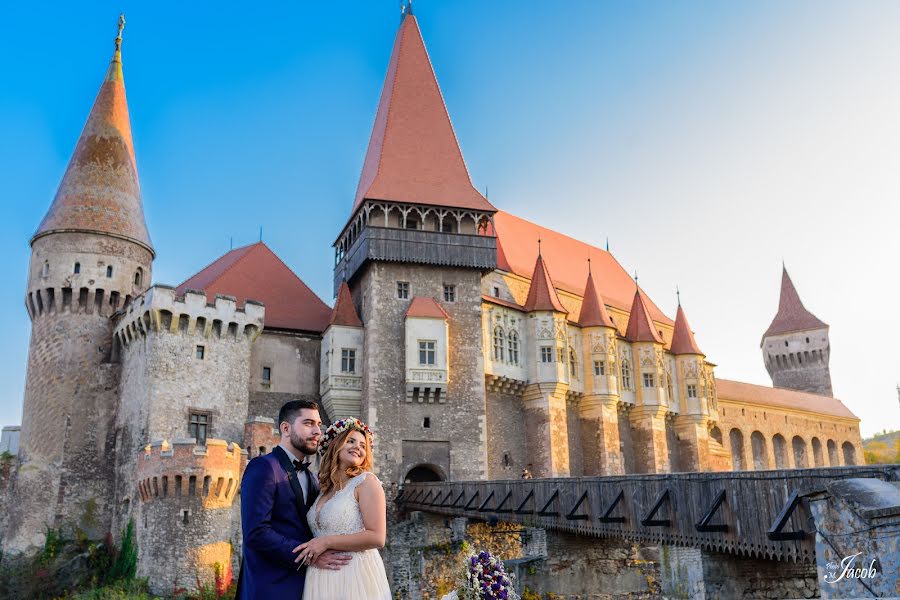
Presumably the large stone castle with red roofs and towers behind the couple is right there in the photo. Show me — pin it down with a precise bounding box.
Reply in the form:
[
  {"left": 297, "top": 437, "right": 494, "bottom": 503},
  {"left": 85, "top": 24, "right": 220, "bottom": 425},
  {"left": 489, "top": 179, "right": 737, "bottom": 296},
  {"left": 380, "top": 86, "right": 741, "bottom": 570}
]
[{"left": 0, "top": 10, "right": 862, "bottom": 590}]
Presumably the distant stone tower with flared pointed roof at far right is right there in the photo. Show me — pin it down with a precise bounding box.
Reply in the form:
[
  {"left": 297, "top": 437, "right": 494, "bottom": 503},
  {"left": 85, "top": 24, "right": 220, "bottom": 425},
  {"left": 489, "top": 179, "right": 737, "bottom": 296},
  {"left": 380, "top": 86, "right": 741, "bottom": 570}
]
[{"left": 760, "top": 268, "right": 834, "bottom": 396}]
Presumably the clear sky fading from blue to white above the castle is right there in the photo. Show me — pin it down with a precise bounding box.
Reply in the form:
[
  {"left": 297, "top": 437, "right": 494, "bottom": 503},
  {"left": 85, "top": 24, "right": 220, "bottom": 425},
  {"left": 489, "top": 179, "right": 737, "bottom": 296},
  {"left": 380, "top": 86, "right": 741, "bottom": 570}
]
[{"left": 0, "top": 0, "right": 900, "bottom": 435}]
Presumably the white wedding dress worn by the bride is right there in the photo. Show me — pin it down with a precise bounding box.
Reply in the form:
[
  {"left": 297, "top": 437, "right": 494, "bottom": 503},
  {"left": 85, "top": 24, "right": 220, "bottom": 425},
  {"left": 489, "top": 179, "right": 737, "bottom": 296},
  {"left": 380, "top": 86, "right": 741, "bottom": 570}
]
[{"left": 303, "top": 472, "right": 391, "bottom": 600}]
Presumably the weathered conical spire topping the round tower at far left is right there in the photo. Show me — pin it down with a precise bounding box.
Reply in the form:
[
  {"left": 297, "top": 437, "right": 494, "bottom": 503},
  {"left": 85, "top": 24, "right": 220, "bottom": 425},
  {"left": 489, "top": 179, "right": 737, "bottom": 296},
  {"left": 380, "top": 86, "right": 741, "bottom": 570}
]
[{"left": 31, "top": 15, "right": 153, "bottom": 254}]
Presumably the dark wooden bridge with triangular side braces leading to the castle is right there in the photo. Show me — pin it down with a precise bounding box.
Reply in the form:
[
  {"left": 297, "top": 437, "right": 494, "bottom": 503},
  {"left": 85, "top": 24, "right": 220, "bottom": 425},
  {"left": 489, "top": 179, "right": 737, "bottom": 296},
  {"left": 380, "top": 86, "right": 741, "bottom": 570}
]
[{"left": 396, "top": 465, "right": 900, "bottom": 562}]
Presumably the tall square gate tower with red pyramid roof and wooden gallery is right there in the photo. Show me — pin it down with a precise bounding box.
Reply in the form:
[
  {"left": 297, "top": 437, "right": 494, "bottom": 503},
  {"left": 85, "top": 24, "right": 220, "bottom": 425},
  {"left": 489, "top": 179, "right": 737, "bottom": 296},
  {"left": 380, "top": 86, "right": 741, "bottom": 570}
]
[{"left": 332, "top": 8, "right": 497, "bottom": 483}]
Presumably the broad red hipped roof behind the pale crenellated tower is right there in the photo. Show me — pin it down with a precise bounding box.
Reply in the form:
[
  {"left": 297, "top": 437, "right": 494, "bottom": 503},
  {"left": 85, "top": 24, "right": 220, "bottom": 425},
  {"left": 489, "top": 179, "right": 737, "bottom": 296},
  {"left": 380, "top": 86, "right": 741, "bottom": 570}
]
[{"left": 176, "top": 242, "right": 331, "bottom": 333}]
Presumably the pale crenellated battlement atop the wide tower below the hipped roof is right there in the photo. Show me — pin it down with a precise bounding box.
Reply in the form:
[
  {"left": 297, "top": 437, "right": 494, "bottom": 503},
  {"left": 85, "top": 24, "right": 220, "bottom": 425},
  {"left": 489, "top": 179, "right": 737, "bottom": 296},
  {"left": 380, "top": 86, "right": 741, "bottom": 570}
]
[{"left": 114, "top": 284, "right": 265, "bottom": 346}]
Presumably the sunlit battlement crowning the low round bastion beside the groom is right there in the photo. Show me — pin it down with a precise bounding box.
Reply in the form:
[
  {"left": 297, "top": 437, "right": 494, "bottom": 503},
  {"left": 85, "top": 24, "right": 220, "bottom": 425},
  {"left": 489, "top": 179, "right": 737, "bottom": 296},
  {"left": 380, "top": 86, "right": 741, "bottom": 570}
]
[{"left": 136, "top": 438, "right": 247, "bottom": 508}]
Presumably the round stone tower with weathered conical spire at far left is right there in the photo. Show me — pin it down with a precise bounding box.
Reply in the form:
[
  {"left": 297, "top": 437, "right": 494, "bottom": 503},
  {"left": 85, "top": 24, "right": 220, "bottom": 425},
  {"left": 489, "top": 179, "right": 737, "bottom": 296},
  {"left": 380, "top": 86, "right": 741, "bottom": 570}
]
[{"left": 4, "top": 18, "right": 154, "bottom": 551}]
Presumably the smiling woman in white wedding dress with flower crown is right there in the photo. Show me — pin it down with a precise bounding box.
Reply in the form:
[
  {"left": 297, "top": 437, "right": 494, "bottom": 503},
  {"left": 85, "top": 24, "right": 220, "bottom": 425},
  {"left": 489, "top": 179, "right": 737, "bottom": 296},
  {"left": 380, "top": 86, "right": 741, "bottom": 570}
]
[{"left": 294, "top": 417, "right": 391, "bottom": 600}]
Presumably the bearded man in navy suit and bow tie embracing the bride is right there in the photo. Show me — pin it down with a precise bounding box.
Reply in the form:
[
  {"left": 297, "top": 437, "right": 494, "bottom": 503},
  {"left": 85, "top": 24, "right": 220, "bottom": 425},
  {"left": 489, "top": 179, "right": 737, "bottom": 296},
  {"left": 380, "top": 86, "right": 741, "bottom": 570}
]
[{"left": 237, "top": 400, "right": 351, "bottom": 600}]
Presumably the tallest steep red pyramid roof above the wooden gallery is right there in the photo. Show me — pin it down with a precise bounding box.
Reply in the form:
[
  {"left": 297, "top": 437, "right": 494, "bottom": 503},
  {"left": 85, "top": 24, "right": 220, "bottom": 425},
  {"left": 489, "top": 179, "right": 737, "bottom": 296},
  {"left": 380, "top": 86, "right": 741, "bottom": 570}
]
[{"left": 353, "top": 14, "right": 496, "bottom": 212}]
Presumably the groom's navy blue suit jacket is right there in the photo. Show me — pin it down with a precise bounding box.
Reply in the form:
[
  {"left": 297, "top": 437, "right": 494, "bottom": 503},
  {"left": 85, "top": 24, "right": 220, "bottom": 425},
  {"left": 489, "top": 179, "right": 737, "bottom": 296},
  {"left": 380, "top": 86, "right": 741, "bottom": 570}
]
[{"left": 237, "top": 446, "right": 319, "bottom": 600}]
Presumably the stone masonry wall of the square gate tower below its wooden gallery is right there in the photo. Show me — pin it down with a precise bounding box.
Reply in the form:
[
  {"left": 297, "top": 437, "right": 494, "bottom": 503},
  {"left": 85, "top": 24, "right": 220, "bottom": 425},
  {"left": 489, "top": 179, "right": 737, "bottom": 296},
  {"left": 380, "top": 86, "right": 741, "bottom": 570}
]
[{"left": 351, "top": 262, "right": 487, "bottom": 482}]
